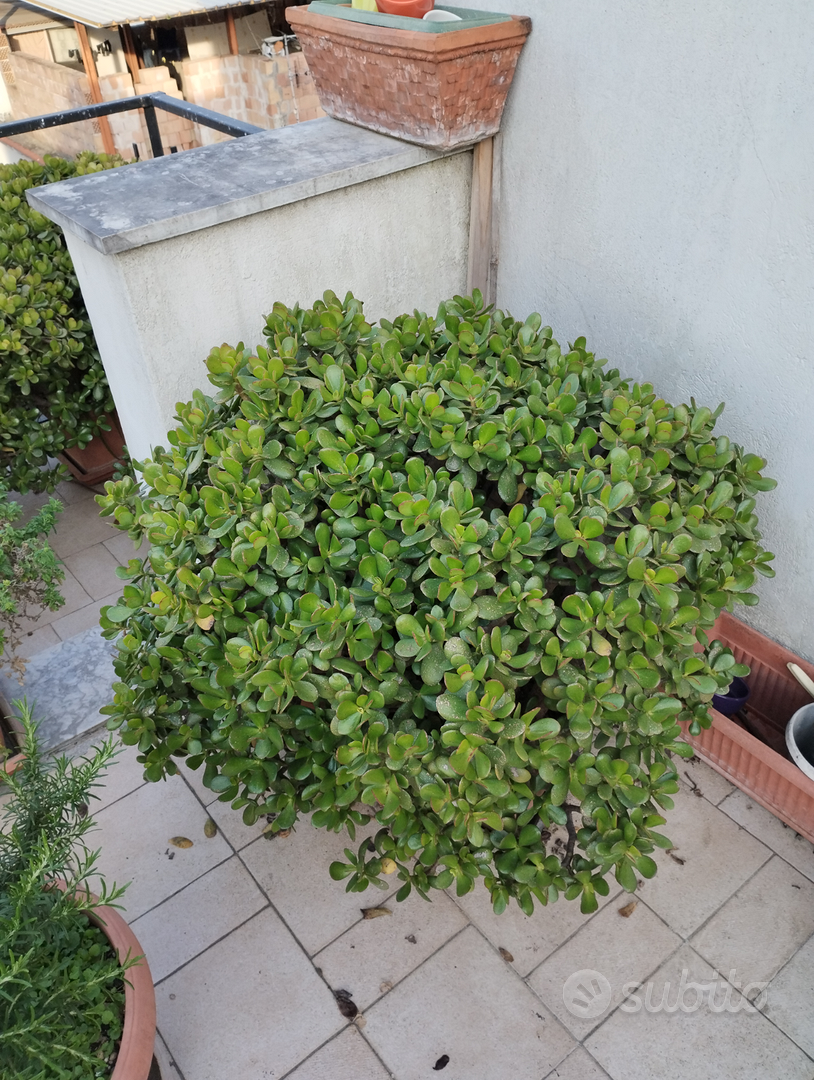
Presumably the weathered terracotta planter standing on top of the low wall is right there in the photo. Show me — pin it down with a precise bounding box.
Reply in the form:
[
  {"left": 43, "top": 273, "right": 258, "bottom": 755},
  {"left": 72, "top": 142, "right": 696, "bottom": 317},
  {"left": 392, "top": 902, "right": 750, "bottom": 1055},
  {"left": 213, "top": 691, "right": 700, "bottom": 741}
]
[{"left": 285, "top": 8, "right": 531, "bottom": 150}]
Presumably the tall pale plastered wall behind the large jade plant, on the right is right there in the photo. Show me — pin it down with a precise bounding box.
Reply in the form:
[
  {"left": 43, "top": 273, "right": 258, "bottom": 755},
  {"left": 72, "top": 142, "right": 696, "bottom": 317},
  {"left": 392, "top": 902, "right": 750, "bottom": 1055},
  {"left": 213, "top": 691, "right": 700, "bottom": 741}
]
[{"left": 478, "top": 0, "right": 814, "bottom": 658}]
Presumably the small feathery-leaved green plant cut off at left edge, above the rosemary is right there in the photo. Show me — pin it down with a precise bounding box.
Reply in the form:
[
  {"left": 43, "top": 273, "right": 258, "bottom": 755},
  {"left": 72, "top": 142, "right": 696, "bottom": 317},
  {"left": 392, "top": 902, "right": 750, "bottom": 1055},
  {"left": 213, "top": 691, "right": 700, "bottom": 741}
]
[{"left": 0, "top": 487, "right": 65, "bottom": 772}]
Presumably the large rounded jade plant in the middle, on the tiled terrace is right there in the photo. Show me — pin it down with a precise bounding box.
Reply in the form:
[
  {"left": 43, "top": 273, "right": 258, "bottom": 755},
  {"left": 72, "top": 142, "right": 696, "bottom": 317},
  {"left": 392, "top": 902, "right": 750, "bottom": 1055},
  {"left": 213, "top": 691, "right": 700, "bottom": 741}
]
[{"left": 98, "top": 293, "right": 774, "bottom": 913}]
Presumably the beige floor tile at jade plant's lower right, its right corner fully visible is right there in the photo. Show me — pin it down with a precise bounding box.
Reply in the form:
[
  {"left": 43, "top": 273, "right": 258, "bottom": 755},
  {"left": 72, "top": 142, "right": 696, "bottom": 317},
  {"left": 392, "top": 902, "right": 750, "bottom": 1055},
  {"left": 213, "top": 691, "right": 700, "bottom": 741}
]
[{"left": 639, "top": 792, "right": 770, "bottom": 937}]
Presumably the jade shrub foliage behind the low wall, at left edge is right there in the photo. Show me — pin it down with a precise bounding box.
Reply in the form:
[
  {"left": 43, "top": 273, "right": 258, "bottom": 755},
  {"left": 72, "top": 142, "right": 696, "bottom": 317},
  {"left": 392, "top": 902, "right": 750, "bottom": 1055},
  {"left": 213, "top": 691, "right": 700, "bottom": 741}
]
[{"left": 0, "top": 152, "right": 123, "bottom": 491}]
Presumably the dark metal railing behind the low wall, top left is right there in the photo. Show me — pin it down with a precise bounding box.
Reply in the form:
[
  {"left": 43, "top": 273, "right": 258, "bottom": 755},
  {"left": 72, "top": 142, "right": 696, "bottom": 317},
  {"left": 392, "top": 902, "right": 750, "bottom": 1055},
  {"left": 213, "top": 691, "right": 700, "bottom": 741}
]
[{"left": 0, "top": 92, "right": 266, "bottom": 158}]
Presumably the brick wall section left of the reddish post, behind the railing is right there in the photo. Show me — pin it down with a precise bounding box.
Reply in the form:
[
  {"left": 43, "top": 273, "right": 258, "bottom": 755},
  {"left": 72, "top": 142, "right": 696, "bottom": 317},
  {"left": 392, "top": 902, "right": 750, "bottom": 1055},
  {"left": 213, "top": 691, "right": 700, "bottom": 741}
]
[{"left": 3, "top": 51, "right": 103, "bottom": 158}]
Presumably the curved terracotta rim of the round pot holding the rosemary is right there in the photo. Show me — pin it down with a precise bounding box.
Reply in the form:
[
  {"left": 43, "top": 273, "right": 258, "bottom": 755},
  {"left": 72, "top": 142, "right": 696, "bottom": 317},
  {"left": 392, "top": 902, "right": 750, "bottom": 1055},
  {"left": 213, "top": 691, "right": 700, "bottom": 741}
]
[{"left": 87, "top": 907, "right": 155, "bottom": 1080}]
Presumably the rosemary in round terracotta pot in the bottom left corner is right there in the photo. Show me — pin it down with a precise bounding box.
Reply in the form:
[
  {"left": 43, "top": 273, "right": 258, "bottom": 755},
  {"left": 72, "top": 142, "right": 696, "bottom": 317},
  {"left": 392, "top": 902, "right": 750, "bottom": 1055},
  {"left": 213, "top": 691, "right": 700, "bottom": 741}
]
[{"left": 0, "top": 702, "right": 155, "bottom": 1080}]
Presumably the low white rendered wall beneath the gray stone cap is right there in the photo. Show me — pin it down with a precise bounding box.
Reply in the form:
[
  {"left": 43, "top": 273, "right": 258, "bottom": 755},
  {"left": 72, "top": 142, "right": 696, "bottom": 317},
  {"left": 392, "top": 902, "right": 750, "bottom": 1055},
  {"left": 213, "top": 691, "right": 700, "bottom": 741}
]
[{"left": 66, "top": 153, "right": 472, "bottom": 468}]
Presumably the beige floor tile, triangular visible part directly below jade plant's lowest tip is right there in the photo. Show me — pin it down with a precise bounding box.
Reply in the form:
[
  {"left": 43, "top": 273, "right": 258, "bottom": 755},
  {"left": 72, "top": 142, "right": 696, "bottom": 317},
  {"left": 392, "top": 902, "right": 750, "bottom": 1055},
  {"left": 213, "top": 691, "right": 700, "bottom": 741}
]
[{"left": 450, "top": 877, "right": 621, "bottom": 976}]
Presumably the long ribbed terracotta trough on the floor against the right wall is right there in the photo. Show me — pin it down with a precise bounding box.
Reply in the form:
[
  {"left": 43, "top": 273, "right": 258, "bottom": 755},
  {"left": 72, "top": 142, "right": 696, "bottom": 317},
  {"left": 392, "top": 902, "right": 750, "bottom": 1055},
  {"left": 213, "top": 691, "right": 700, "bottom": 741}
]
[{"left": 684, "top": 613, "right": 814, "bottom": 843}]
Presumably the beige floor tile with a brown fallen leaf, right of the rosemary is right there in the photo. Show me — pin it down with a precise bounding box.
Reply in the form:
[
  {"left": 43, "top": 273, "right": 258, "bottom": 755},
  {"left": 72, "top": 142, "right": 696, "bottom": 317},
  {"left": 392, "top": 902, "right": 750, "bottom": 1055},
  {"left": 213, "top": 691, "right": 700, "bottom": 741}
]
[{"left": 92, "top": 777, "right": 232, "bottom": 921}]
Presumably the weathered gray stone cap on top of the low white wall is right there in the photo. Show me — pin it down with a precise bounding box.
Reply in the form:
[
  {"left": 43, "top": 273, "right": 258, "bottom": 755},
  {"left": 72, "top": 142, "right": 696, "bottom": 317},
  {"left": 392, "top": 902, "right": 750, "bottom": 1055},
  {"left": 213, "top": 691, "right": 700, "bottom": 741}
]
[{"left": 26, "top": 117, "right": 459, "bottom": 255}]
